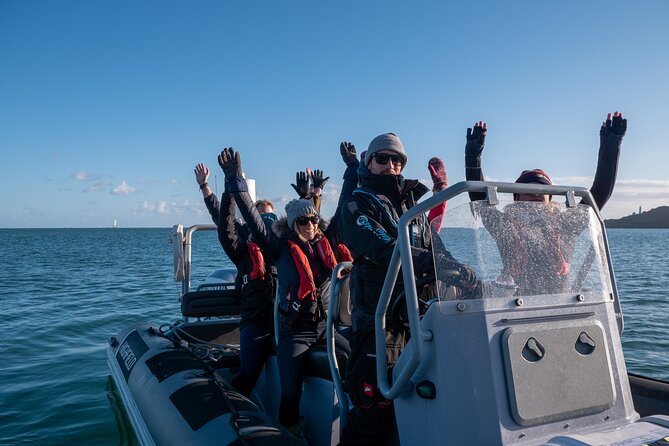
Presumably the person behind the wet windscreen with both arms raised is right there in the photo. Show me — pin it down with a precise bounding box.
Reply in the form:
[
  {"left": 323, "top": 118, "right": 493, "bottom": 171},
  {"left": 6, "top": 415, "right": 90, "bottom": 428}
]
[{"left": 465, "top": 112, "right": 627, "bottom": 295}]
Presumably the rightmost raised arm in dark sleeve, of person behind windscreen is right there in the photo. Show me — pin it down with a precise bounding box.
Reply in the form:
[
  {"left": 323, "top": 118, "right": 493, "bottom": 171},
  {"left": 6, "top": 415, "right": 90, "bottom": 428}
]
[{"left": 590, "top": 112, "right": 627, "bottom": 209}]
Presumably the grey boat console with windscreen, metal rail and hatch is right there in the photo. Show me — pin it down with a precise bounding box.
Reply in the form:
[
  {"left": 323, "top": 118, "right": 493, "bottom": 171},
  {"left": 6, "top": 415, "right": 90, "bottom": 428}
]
[{"left": 366, "top": 182, "right": 669, "bottom": 446}]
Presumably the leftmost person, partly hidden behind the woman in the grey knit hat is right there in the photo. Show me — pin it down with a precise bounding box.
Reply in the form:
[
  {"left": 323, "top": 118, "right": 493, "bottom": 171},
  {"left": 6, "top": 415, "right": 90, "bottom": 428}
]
[{"left": 195, "top": 163, "right": 277, "bottom": 396}]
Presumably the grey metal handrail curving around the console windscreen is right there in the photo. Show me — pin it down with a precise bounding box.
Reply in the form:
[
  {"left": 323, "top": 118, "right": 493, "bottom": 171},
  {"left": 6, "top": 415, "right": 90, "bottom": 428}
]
[{"left": 374, "top": 181, "right": 623, "bottom": 400}]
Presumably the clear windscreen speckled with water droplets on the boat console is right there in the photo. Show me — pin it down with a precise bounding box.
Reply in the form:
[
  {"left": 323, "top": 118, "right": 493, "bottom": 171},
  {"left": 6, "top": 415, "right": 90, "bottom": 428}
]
[{"left": 431, "top": 201, "right": 612, "bottom": 300}]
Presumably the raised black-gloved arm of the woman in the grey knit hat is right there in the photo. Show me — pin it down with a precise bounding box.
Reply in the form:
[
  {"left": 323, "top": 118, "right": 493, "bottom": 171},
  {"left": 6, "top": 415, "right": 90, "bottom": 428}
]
[{"left": 218, "top": 147, "right": 279, "bottom": 258}]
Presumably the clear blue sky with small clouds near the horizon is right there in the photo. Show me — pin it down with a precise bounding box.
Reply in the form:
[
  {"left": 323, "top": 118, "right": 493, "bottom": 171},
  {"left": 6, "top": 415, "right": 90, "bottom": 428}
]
[{"left": 0, "top": 0, "right": 669, "bottom": 227}]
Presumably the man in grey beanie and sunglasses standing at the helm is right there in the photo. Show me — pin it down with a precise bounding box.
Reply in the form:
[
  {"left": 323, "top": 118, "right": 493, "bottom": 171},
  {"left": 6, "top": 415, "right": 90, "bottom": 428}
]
[{"left": 341, "top": 133, "right": 476, "bottom": 445}]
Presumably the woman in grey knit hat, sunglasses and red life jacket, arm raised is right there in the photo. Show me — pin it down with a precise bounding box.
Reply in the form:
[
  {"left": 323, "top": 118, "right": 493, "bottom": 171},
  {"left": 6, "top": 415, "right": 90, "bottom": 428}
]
[{"left": 219, "top": 148, "right": 350, "bottom": 434}]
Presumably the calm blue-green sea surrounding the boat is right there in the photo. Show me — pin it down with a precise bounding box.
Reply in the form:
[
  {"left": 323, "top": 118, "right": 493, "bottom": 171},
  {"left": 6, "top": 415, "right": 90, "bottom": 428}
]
[{"left": 0, "top": 229, "right": 669, "bottom": 445}]
